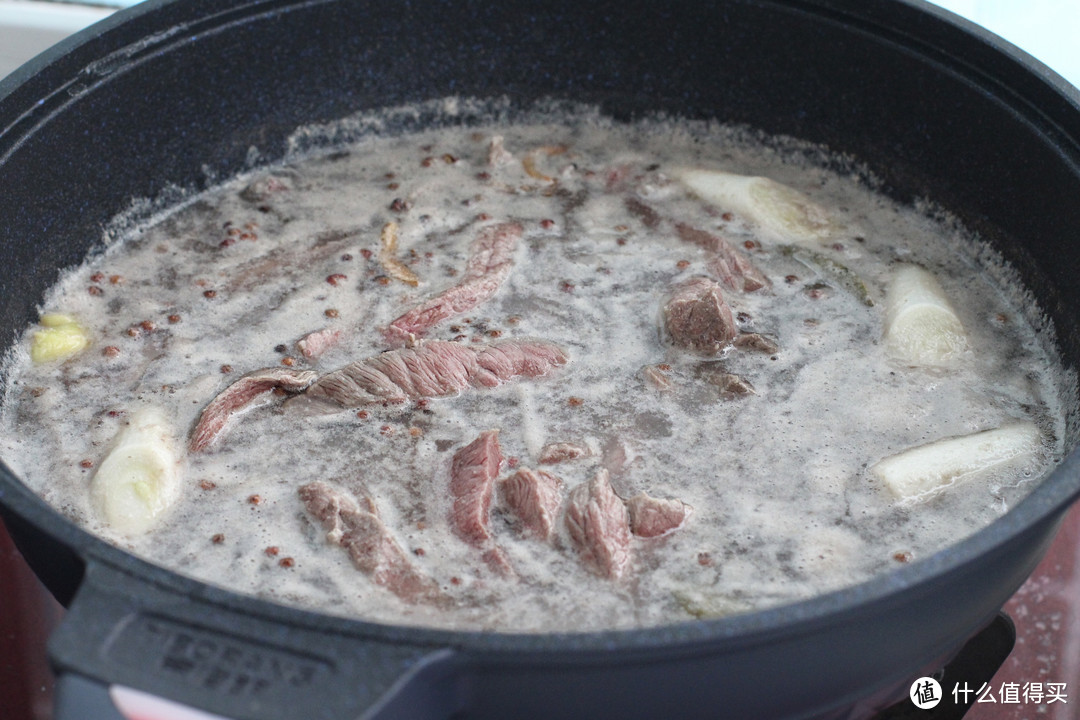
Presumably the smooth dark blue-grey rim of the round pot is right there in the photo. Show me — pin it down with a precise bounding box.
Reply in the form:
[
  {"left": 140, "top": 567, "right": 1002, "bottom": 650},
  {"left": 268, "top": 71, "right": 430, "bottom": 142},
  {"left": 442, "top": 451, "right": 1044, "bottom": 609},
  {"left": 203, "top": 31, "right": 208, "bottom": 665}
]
[{"left": 0, "top": 0, "right": 1080, "bottom": 653}]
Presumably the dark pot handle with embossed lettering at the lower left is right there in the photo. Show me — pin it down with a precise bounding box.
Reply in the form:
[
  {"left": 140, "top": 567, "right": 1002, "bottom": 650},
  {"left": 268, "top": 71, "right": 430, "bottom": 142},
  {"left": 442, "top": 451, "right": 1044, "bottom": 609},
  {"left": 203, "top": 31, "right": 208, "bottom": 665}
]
[{"left": 49, "top": 562, "right": 463, "bottom": 720}]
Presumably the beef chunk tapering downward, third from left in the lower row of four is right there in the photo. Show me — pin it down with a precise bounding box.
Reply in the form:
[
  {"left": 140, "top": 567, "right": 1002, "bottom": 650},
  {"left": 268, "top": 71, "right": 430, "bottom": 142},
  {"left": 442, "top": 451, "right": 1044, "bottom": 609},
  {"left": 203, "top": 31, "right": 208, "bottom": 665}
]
[{"left": 566, "top": 470, "right": 631, "bottom": 580}]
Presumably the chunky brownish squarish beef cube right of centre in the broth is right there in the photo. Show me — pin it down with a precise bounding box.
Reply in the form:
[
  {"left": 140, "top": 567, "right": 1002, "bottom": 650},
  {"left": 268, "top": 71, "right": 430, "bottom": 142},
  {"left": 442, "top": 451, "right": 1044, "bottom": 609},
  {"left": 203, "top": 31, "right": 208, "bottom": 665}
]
[{"left": 664, "top": 277, "right": 739, "bottom": 355}]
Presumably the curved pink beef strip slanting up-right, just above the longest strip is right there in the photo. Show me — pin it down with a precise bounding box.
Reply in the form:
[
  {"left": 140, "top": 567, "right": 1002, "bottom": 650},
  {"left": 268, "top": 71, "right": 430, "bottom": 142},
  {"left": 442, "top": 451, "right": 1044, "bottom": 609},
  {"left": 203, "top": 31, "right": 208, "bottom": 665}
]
[{"left": 387, "top": 222, "right": 523, "bottom": 342}]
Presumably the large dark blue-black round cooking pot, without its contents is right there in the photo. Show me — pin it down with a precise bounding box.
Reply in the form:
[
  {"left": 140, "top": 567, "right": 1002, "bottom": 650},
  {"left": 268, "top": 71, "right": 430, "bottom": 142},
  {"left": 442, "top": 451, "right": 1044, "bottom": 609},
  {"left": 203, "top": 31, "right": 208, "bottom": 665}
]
[{"left": 0, "top": 0, "right": 1080, "bottom": 720}]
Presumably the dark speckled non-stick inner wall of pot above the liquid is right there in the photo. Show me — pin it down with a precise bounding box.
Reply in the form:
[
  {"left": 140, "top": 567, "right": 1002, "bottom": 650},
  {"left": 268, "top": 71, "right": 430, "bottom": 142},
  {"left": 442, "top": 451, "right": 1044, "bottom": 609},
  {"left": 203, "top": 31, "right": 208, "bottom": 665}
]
[{"left": 0, "top": 0, "right": 1080, "bottom": 716}]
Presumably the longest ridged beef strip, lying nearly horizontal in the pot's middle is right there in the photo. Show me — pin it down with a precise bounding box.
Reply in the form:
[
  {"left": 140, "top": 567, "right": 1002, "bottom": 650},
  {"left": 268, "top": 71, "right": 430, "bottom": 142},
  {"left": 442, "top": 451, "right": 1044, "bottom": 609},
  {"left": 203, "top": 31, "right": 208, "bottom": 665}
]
[{"left": 298, "top": 340, "right": 567, "bottom": 408}]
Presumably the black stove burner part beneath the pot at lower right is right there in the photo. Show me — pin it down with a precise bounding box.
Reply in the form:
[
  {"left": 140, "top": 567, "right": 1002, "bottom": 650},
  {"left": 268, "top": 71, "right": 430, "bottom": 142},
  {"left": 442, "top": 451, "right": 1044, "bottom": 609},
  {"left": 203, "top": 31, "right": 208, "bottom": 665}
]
[{"left": 874, "top": 612, "right": 1016, "bottom": 720}]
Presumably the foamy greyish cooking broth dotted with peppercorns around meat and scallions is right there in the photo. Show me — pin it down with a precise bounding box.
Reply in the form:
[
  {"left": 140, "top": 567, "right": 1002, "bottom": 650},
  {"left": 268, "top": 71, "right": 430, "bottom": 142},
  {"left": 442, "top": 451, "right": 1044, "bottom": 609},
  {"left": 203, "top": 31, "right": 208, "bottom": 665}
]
[{"left": 2, "top": 101, "right": 1071, "bottom": 631}]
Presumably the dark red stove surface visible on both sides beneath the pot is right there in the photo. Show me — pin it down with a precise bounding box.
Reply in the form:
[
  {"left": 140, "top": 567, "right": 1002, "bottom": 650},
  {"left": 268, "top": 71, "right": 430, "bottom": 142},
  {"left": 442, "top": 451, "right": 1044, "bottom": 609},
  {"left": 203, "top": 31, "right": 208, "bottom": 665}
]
[{"left": 0, "top": 505, "right": 1080, "bottom": 720}]
